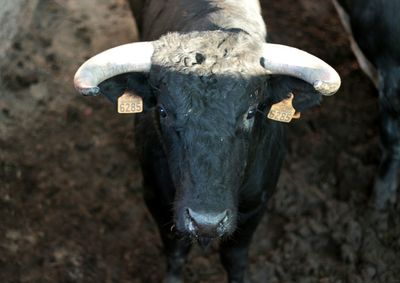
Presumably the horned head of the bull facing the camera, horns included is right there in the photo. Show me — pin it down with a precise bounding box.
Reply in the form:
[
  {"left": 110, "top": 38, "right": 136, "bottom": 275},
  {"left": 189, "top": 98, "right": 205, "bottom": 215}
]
[{"left": 75, "top": 31, "right": 340, "bottom": 242}]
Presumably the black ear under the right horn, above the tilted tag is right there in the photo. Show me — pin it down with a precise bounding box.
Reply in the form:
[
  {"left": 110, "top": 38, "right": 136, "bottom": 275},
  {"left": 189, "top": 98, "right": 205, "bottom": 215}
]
[{"left": 266, "top": 75, "right": 322, "bottom": 112}]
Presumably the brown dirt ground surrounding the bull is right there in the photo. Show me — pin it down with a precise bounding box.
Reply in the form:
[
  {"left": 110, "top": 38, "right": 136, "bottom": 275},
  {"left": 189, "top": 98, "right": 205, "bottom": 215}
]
[{"left": 0, "top": 0, "right": 400, "bottom": 283}]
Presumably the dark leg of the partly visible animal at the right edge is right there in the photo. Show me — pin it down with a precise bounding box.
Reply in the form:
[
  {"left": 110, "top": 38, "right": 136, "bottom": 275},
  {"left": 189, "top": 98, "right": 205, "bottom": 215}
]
[{"left": 373, "top": 70, "right": 400, "bottom": 209}]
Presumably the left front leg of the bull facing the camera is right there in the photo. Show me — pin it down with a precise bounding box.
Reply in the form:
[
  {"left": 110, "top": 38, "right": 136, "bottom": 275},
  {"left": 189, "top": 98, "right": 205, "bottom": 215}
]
[{"left": 145, "top": 187, "right": 191, "bottom": 283}]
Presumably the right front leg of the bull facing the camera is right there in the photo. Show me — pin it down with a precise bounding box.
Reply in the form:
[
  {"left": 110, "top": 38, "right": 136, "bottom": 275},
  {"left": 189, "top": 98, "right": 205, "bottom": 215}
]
[{"left": 220, "top": 208, "right": 264, "bottom": 283}]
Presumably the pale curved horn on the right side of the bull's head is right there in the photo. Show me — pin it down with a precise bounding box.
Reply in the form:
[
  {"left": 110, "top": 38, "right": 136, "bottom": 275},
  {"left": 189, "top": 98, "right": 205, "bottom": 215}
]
[{"left": 262, "top": 43, "right": 340, "bottom": 95}]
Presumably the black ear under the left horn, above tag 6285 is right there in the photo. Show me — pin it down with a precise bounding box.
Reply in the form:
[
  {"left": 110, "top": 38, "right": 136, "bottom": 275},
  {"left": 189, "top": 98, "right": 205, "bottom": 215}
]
[{"left": 99, "top": 73, "right": 156, "bottom": 111}]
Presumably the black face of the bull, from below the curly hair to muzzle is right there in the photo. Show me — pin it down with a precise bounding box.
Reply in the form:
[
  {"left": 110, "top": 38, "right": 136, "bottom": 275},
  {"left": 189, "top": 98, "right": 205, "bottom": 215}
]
[{"left": 151, "top": 72, "right": 265, "bottom": 240}]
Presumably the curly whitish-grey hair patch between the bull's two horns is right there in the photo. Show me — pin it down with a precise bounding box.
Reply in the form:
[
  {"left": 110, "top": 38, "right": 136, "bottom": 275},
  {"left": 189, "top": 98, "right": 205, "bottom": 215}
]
[{"left": 152, "top": 31, "right": 265, "bottom": 77}]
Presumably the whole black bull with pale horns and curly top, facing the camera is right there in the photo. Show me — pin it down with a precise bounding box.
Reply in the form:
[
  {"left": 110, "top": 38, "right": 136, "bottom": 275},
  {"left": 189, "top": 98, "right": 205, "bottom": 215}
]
[{"left": 75, "top": 1, "right": 340, "bottom": 282}]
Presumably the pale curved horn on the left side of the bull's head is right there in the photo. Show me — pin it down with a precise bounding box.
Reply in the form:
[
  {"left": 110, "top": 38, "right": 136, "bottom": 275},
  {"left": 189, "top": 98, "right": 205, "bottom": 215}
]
[{"left": 74, "top": 42, "right": 154, "bottom": 95}]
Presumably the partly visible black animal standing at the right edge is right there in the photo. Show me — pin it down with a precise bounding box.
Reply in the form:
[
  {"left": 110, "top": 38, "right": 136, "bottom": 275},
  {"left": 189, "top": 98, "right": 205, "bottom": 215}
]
[{"left": 334, "top": 0, "right": 400, "bottom": 209}]
